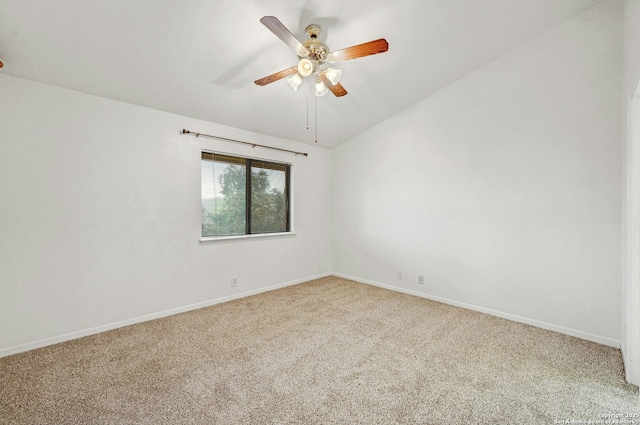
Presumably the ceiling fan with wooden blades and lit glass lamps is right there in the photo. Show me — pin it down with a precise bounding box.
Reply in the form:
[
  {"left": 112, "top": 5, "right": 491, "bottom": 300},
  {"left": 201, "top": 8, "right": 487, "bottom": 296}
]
[{"left": 255, "top": 16, "right": 389, "bottom": 97}]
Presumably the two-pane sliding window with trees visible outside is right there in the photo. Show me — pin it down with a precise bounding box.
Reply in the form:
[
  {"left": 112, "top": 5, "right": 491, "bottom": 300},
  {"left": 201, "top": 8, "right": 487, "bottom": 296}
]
[{"left": 201, "top": 152, "right": 290, "bottom": 237}]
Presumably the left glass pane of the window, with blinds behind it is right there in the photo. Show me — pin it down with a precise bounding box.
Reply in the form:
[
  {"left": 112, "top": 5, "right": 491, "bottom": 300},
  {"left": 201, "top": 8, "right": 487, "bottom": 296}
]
[{"left": 201, "top": 152, "right": 246, "bottom": 236}]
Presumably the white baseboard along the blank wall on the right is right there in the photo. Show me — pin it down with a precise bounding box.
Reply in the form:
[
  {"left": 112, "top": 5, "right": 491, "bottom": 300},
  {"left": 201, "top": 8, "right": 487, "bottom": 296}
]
[{"left": 333, "top": 273, "right": 620, "bottom": 349}]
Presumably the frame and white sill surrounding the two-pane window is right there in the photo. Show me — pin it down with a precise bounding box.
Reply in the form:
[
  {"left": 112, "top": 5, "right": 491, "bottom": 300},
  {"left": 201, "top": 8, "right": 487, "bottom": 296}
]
[{"left": 200, "top": 149, "right": 296, "bottom": 243}]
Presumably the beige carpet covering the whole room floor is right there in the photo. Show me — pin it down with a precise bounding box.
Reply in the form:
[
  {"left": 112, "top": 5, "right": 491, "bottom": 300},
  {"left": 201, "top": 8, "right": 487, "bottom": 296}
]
[{"left": 0, "top": 277, "right": 640, "bottom": 424}]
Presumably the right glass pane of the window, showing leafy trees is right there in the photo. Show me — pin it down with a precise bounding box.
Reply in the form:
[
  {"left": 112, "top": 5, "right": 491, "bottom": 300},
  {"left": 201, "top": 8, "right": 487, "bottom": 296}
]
[{"left": 251, "top": 161, "right": 288, "bottom": 233}]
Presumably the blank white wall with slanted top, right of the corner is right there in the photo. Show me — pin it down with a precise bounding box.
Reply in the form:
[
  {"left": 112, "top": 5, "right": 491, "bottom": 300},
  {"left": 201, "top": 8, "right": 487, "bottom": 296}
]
[{"left": 333, "top": 1, "right": 623, "bottom": 346}]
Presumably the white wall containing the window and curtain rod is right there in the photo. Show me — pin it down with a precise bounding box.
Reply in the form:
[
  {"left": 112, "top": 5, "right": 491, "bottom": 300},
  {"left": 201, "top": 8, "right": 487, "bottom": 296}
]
[{"left": 0, "top": 75, "right": 331, "bottom": 356}]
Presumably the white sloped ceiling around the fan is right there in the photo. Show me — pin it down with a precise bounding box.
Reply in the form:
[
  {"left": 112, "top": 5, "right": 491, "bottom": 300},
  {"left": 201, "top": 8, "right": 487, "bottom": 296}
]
[{"left": 0, "top": 0, "right": 599, "bottom": 148}]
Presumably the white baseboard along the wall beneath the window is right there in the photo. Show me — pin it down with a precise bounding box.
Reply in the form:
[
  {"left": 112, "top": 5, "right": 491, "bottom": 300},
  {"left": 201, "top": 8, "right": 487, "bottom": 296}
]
[{"left": 0, "top": 273, "right": 333, "bottom": 358}]
